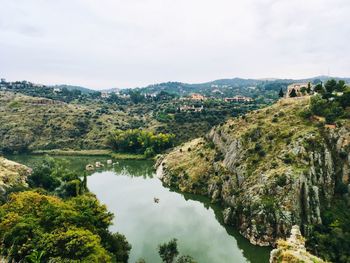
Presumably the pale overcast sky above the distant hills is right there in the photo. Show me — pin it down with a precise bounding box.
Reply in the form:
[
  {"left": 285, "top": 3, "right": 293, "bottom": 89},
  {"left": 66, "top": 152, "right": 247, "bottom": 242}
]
[{"left": 0, "top": 0, "right": 350, "bottom": 89}]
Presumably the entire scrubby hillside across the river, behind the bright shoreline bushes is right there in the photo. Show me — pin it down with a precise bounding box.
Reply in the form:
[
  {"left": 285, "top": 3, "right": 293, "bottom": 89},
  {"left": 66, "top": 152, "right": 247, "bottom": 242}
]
[{"left": 0, "top": 91, "right": 262, "bottom": 153}]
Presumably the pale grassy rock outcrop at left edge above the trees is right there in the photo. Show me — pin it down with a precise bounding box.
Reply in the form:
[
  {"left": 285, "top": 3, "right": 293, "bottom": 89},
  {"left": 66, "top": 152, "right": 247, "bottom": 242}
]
[{"left": 0, "top": 156, "right": 31, "bottom": 193}]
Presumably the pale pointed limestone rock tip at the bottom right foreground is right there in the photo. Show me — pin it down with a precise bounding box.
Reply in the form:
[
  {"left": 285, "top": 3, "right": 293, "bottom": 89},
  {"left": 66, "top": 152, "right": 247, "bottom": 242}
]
[{"left": 270, "top": 225, "right": 324, "bottom": 263}]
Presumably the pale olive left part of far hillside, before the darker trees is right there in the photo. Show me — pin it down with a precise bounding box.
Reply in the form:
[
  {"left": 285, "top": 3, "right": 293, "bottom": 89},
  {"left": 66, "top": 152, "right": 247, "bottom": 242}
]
[{"left": 0, "top": 92, "right": 153, "bottom": 152}]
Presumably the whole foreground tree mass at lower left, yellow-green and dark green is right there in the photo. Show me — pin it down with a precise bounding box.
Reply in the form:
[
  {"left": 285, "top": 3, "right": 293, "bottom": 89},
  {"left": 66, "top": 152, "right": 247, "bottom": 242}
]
[{"left": 0, "top": 159, "right": 131, "bottom": 263}]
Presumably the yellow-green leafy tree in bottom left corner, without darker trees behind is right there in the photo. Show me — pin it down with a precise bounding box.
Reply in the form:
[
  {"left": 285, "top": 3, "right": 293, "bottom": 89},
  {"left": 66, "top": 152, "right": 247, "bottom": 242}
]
[{"left": 0, "top": 191, "right": 130, "bottom": 263}]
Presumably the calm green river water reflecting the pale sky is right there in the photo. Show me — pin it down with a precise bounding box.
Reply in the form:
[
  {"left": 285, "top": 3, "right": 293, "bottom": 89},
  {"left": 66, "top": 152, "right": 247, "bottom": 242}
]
[{"left": 9, "top": 156, "right": 270, "bottom": 263}]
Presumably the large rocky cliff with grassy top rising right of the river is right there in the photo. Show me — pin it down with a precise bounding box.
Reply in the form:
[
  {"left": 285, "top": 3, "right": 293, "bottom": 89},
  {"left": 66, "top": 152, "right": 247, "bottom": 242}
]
[{"left": 157, "top": 98, "right": 350, "bottom": 250}]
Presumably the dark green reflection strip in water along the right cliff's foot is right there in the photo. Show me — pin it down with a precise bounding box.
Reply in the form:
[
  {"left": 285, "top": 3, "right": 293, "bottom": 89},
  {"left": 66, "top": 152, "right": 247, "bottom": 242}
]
[{"left": 170, "top": 188, "right": 271, "bottom": 263}]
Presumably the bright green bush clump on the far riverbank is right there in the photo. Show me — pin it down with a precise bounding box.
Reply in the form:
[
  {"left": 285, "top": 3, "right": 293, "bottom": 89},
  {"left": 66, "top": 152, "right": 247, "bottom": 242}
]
[{"left": 109, "top": 129, "right": 175, "bottom": 157}]
